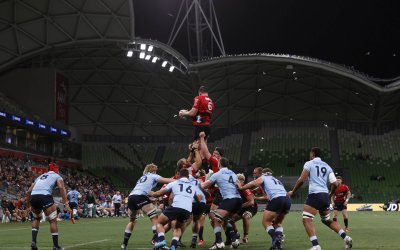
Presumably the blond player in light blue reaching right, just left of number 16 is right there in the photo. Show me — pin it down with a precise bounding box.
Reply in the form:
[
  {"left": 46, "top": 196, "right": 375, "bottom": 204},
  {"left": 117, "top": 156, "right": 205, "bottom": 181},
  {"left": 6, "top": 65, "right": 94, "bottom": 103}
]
[{"left": 121, "top": 163, "right": 175, "bottom": 249}]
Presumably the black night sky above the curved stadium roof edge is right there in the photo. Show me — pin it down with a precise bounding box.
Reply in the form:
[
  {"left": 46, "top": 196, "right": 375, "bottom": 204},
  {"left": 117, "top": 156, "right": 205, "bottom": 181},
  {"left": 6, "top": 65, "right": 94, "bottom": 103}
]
[{"left": 134, "top": 0, "right": 400, "bottom": 78}]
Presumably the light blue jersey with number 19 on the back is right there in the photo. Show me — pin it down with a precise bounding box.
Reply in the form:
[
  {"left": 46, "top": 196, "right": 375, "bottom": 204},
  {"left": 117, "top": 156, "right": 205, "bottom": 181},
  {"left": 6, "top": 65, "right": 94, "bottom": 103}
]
[{"left": 304, "top": 157, "right": 334, "bottom": 194}]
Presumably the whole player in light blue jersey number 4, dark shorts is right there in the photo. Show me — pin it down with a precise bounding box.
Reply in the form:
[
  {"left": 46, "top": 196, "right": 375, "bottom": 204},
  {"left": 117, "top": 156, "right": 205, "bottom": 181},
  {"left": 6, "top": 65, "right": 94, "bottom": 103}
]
[{"left": 201, "top": 157, "right": 242, "bottom": 250}]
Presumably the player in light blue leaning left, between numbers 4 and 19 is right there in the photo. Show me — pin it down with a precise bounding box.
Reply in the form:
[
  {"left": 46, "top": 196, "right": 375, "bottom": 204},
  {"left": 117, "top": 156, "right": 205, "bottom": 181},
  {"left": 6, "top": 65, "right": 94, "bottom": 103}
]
[{"left": 238, "top": 168, "right": 292, "bottom": 250}]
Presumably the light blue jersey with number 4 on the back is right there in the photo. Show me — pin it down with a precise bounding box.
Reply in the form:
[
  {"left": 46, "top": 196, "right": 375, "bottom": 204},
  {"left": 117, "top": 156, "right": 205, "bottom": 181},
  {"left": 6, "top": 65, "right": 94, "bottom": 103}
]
[{"left": 210, "top": 168, "right": 241, "bottom": 199}]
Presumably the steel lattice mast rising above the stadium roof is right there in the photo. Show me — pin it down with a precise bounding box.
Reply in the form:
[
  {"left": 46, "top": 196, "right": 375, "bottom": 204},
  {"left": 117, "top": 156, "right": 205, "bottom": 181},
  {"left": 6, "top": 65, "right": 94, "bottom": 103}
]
[{"left": 168, "top": 0, "right": 225, "bottom": 62}]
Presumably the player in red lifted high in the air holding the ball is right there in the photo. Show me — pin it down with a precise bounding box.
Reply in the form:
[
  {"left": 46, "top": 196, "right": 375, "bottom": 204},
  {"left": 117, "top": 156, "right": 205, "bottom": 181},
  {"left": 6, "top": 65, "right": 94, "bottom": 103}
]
[{"left": 179, "top": 86, "right": 214, "bottom": 140}]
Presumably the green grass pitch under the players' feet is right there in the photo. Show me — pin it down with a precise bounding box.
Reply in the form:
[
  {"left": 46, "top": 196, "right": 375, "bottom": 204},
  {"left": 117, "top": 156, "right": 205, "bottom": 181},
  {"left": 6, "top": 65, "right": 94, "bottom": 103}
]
[{"left": 0, "top": 212, "right": 400, "bottom": 250}]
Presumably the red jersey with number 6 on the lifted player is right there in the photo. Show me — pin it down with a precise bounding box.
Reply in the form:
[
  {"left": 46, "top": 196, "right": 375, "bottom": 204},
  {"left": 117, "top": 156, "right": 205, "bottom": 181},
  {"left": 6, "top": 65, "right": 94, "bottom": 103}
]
[{"left": 193, "top": 95, "right": 214, "bottom": 126}]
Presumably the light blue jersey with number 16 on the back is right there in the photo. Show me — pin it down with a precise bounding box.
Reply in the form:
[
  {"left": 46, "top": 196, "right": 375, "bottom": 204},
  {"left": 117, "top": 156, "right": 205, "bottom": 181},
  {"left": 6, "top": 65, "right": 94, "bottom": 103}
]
[{"left": 165, "top": 178, "right": 201, "bottom": 212}]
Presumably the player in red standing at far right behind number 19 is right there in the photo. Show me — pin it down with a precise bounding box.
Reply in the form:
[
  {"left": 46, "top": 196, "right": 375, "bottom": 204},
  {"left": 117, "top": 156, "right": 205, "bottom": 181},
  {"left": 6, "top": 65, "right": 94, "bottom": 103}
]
[{"left": 332, "top": 176, "right": 351, "bottom": 232}]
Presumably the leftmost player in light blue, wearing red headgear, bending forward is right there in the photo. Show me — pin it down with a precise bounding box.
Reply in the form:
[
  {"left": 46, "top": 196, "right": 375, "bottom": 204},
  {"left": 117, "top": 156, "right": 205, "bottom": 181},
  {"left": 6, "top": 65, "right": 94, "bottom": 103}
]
[{"left": 26, "top": 166, "right": 71, "bottom": 250}]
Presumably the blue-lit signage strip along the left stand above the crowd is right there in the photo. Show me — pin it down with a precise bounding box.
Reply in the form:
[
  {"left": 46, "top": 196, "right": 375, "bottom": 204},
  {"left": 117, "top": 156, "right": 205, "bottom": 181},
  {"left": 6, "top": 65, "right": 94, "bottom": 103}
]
[{"left": 0, "top": 111, "right": 71, "bottom": 137}]
